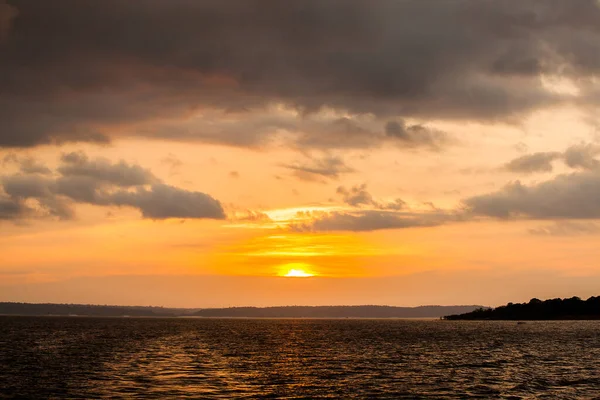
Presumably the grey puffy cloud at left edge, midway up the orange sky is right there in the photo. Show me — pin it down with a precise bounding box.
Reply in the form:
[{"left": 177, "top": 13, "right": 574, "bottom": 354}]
[{"left": 0, "top": 153, "right": 225, "bottom": 220}]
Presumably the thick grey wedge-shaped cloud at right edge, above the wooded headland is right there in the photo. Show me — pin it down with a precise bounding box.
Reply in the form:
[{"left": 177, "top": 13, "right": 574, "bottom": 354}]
[{"left": 463, "top": 170, "right": 600, "bottom": 219}]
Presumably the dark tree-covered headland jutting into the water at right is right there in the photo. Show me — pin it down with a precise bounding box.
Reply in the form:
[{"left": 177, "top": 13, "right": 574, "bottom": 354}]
[{"left": 444, "top": 296, "right": 600, "bottom": 321}]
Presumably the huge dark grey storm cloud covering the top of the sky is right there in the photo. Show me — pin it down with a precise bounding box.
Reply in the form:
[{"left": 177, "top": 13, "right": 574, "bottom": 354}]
[{"left": 0, "top": 0, "right": 600, "bottom": 147}]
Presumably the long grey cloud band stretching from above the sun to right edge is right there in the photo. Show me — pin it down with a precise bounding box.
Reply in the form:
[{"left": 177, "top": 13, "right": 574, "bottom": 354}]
[{"left": 289, "top": 162, "right": 600, "bottom": 230}]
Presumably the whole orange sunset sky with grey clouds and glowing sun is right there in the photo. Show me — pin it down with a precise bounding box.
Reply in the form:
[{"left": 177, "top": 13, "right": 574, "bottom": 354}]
[{"left": 0, "top": 0, "right": 600, "bottom": 307}]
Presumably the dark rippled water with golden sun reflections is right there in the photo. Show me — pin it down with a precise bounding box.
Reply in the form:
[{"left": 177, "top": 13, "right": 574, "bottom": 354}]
[{"left": 0, "top": 317, "right": 600, "bottom": 399}]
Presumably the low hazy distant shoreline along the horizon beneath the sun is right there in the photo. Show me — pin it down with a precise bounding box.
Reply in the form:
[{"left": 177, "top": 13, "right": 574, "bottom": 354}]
[{"left": 0, "top": 303, "right": 481, "bottom": 318}]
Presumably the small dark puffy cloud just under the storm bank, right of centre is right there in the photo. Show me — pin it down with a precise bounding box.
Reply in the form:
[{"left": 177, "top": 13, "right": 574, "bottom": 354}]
[{"left": 385, "top": 120, "right": 450, "bottom": 150}]
